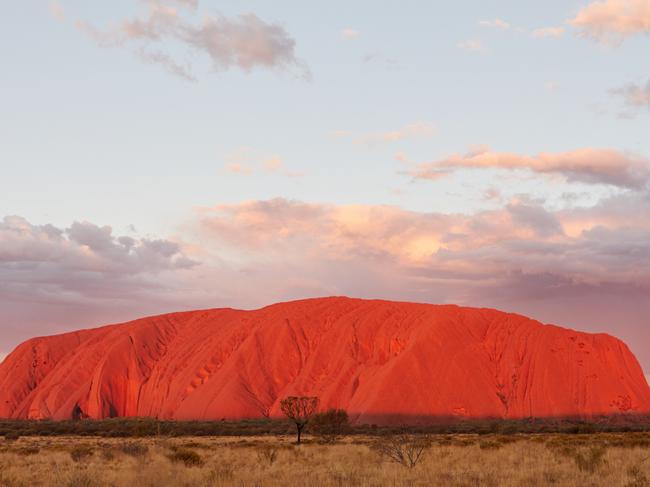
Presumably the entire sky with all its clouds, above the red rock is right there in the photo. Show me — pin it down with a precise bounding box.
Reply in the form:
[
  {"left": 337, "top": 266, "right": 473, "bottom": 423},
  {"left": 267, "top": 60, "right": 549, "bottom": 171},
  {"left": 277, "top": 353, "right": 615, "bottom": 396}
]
[{"left": 0, "top": 0, "right": 650, "bottom": 382}]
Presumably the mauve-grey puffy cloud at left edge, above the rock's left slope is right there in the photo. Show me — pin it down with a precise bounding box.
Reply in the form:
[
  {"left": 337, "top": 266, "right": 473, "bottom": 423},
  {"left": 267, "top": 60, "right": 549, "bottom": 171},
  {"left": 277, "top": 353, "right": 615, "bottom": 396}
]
[{"left": 0, "top": 216, "right": 196, "bottom": 299}]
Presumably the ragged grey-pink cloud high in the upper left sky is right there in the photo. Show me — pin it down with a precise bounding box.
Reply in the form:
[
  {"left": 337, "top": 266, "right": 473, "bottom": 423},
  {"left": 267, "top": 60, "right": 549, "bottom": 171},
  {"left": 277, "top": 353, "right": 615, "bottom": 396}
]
[{"left": 76, "top": 2, "right": 309, "bottom": 81}]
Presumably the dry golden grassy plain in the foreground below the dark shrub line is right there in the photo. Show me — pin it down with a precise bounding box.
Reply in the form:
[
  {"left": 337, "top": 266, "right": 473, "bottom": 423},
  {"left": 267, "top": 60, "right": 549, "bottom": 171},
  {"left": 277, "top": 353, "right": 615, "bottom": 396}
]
[{"left": 0, "top": 433, "right": 650, "bottom": 487}]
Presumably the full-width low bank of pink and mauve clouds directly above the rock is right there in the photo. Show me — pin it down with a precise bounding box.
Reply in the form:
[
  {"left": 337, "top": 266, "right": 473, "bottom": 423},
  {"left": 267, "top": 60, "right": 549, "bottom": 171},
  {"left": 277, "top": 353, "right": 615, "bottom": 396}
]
[{"left": 0, "top": 190, "right": 650, "bottom": 370}]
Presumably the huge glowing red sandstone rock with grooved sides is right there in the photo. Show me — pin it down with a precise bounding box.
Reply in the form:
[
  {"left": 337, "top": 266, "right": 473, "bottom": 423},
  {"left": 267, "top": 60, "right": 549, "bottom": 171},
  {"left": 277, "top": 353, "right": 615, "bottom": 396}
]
[{"left": 0, "top": 297, "right": 650, "bottom": 424}]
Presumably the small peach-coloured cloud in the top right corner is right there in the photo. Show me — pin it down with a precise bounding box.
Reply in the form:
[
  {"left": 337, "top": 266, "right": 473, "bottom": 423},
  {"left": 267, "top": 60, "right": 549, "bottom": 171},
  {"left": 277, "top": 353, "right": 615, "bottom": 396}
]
[{"left": 569, "top": 0, "right": 650, "bottom": 44}]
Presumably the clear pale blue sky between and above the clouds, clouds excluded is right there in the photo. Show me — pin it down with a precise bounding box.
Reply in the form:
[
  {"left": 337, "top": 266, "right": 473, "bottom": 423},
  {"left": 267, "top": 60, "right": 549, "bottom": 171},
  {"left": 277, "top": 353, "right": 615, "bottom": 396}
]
[{"left": 0, "top": 0, "right": 650, "bottom": 232}]
